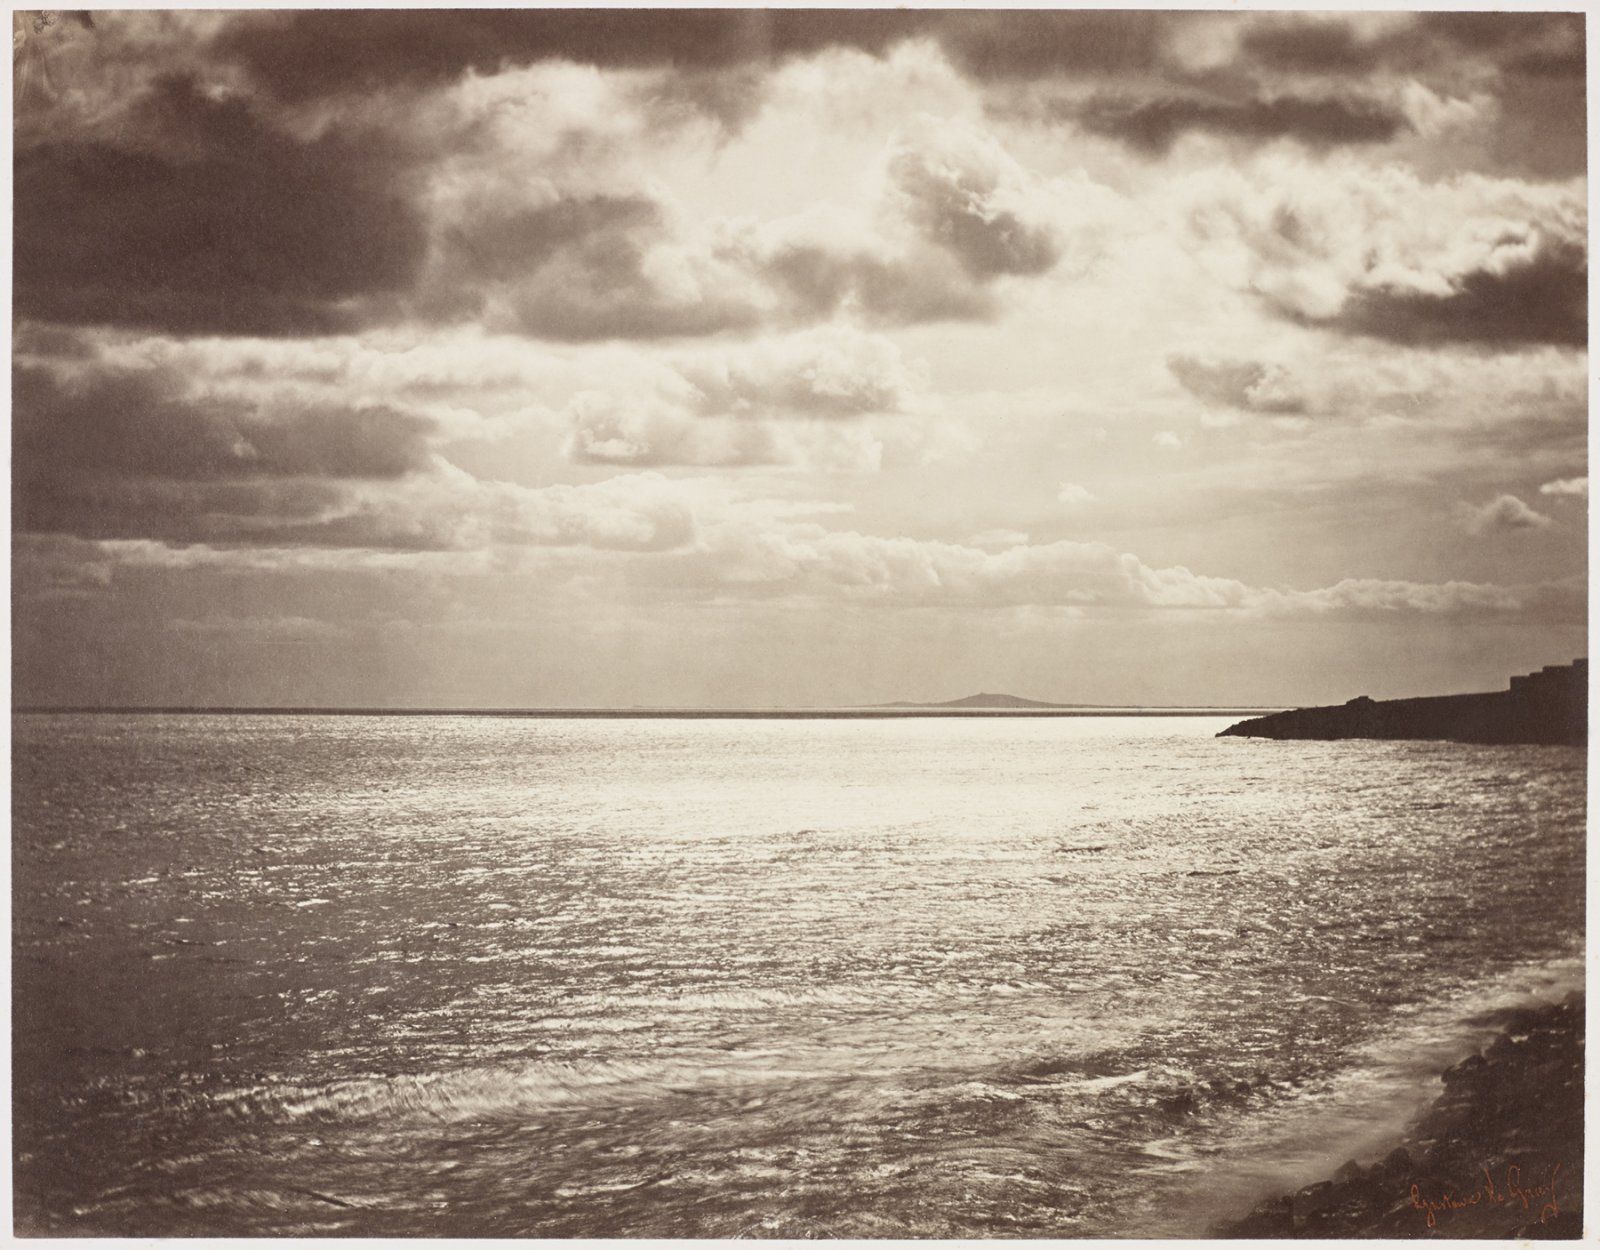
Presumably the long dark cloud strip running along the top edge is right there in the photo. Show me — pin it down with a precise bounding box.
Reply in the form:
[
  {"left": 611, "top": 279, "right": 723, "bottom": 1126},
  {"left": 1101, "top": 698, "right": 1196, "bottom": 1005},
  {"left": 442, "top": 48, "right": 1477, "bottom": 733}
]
[{"left": 214, "top": 10, "right": 1584, "bottom": 99}]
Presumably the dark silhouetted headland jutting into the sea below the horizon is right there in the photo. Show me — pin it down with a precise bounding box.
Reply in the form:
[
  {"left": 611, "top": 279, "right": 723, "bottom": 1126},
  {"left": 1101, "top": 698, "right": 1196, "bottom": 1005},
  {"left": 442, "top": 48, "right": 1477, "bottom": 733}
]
[{"left": 1218, "top": 659, "right": 1589, "bottom": 746}]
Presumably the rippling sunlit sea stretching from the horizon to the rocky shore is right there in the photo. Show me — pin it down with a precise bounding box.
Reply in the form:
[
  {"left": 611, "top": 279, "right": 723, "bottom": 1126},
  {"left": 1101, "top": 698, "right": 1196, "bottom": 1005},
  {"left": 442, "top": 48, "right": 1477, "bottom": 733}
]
[{"left": 13, "top": 714, "right": 1584, "bottom": 1237}]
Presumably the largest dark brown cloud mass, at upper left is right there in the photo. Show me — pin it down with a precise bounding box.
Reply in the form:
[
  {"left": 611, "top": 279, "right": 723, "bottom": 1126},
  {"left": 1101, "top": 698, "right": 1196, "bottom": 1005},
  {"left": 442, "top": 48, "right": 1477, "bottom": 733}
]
[{"left": 14, "top": 77, "right": 427, "bottom": 335}]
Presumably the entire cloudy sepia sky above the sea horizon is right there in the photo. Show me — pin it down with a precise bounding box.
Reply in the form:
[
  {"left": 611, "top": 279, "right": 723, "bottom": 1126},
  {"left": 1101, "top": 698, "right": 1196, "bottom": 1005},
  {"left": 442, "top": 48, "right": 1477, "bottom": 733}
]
[{"left": 13, "top": 10, "right": 1587, "bottom": 706}]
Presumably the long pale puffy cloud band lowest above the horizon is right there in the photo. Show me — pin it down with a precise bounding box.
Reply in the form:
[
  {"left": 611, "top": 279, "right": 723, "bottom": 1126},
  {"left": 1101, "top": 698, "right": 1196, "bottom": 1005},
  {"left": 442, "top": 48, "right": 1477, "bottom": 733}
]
[{"left": 29, "top": 505, "right": 1586, "bottom": 623}]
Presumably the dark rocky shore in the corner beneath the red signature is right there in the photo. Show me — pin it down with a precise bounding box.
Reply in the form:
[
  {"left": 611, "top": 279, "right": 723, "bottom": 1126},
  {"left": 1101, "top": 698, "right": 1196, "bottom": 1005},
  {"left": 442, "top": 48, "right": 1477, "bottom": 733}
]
[{"left": 1213, "top": 994, "right": 1584, "bottom": 1239}]
